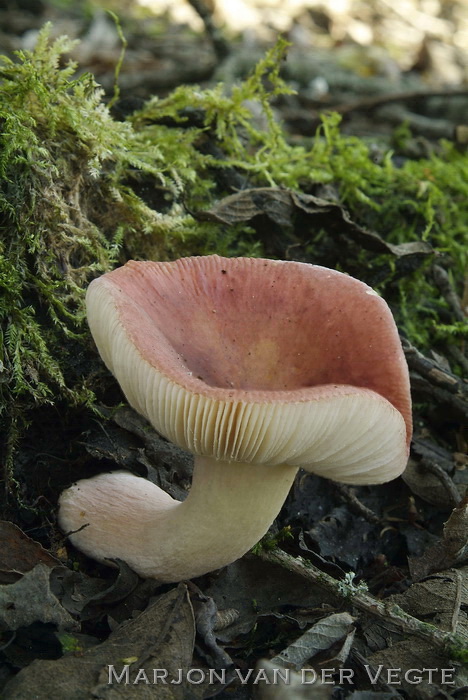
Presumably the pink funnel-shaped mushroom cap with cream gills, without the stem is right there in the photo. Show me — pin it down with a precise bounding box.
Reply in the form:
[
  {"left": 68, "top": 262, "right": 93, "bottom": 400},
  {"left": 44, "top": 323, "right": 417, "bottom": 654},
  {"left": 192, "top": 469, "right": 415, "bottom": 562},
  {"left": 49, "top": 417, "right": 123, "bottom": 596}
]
[{"left": 87, "top": 255, "right": 411, "bottom": 483}]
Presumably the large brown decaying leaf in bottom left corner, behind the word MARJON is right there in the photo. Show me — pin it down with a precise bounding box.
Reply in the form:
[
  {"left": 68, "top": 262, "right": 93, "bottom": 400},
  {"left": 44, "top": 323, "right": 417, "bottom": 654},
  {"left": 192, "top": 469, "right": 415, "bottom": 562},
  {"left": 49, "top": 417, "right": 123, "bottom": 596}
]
[{"left": 5, "top": 584, "right": 195, "bottom": 700}]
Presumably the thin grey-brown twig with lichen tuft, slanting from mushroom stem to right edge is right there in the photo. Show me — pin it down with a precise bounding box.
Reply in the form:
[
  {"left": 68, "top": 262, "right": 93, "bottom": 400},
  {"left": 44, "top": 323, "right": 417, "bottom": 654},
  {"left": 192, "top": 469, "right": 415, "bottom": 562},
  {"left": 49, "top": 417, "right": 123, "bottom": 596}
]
[{"left": 257, "top": 547, "right": 468, "bottom": 660}]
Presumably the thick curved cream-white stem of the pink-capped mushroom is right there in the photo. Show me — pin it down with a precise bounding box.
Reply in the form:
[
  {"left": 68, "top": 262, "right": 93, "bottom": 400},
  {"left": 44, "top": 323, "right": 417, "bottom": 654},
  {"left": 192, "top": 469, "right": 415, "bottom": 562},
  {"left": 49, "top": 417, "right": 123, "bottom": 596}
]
[{"left": 59, "top": 457, "right": 297, "bottom": 582}]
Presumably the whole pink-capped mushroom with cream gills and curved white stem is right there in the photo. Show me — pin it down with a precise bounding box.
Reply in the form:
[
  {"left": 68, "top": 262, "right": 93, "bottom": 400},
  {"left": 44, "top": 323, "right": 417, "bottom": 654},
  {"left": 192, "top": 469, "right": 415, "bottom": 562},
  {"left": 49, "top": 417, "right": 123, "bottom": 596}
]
[{"left": 59, "top": 255, "right": 411, "bottom": 582}]
